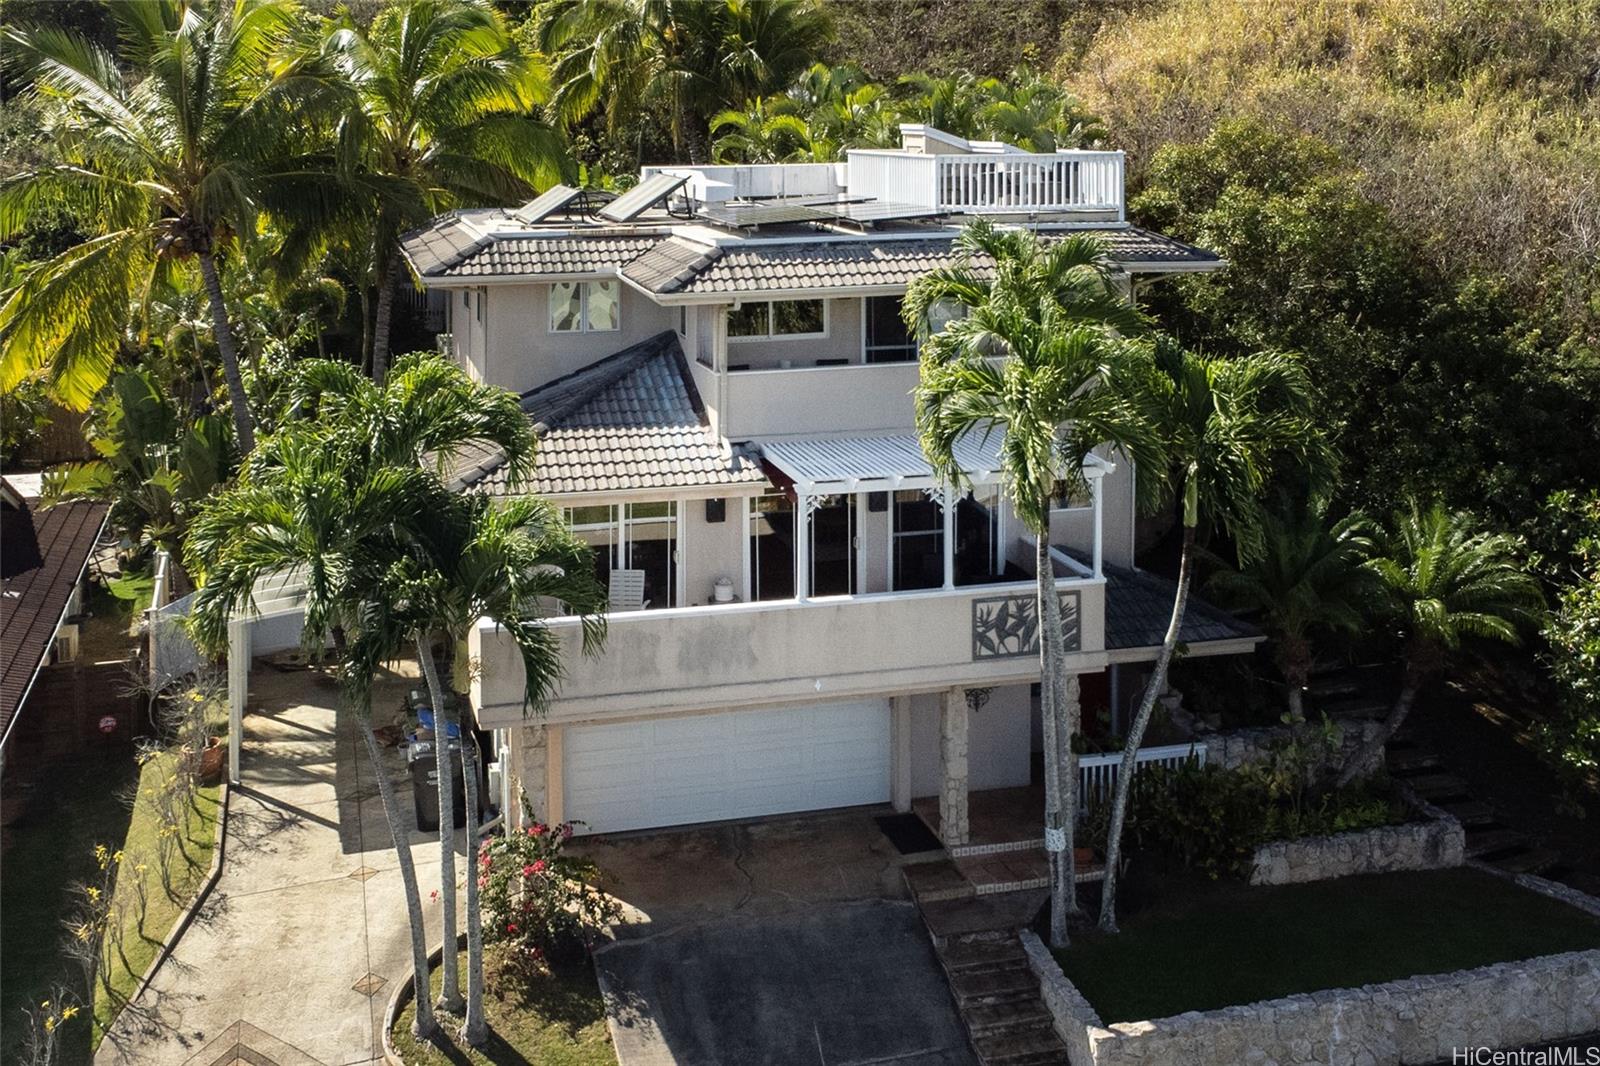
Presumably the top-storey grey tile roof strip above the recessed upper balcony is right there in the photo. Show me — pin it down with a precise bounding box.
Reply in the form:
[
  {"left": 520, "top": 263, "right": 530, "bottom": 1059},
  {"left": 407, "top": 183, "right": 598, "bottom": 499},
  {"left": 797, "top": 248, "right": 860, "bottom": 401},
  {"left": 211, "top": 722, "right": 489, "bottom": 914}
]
[{"left": 622, "top": 226, "right": 1221, "bottom": 295}]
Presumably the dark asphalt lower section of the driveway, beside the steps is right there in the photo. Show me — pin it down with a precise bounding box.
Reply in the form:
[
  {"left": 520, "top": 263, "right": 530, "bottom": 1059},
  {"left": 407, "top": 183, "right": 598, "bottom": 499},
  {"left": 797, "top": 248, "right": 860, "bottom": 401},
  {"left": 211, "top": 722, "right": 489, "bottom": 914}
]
[{"left": 597, "top": 900, "right": 976, "bottom": 1066}]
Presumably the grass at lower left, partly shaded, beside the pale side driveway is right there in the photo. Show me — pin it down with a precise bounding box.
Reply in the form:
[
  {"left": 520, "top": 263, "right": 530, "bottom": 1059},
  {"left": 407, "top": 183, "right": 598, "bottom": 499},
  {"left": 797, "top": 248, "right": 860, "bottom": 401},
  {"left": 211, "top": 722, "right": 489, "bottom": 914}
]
[{"left": 0, "top": 751, "right": 218, "bottom": 1066}]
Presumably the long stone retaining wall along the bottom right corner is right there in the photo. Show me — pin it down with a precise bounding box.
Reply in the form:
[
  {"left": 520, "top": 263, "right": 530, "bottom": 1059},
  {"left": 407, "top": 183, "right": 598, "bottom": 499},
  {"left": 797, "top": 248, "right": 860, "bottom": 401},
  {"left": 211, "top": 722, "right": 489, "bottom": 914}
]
[{"left": 1024, "top": 938, "right": 1600, "bottom": 1066}]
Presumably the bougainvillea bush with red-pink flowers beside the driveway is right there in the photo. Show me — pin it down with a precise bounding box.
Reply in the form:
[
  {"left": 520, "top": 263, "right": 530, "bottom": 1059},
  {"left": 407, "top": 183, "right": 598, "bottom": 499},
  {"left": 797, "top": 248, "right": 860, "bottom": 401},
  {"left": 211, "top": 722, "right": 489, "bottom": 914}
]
[{"left": 478, "top": 795, "right": 622, "bottom": 976}]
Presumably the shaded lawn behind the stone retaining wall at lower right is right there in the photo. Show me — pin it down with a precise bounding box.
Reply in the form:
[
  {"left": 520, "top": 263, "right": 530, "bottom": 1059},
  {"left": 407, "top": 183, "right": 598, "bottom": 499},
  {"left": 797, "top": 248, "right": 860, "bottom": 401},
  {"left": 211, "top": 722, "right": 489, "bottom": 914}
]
[{"left": 1056, "top": 869, "right": 1600, "bottom": 1023}]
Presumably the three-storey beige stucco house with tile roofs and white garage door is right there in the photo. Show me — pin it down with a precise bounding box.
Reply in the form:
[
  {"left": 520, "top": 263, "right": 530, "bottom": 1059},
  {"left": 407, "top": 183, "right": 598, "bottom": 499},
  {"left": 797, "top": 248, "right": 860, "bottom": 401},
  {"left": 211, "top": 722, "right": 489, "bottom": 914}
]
[{"left": 405, "top": 126, "right": 1259, "bottom": 842}]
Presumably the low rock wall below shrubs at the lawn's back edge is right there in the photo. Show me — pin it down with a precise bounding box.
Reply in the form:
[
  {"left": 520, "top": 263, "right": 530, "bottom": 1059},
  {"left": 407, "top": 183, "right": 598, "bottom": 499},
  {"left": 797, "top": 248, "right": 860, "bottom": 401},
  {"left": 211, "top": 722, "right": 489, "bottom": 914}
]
[{"left": 1250, "top": 812, "right": 1467, "bottom": 885}]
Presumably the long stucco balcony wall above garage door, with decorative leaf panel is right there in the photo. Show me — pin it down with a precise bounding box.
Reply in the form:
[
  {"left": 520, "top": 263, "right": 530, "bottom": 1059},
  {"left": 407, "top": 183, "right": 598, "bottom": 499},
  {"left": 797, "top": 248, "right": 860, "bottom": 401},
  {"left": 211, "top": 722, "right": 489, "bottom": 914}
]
[{"left": 469, "top": 578, "right": 1106, "bottom": 728}]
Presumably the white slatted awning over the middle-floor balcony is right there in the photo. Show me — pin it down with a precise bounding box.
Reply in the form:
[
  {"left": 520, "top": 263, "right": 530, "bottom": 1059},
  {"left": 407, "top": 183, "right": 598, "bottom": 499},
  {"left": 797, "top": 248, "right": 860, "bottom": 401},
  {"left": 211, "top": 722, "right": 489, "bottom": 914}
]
[{"left": 760, "top": 431, "right": 1115, "bottom": 496}]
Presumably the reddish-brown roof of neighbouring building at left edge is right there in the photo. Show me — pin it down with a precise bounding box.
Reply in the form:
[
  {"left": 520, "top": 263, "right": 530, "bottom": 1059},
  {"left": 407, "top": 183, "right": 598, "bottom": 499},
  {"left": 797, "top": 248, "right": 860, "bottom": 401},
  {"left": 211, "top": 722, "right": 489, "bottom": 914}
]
[{"left": 0, "top": 501, "right": 107, "bottom": 744}]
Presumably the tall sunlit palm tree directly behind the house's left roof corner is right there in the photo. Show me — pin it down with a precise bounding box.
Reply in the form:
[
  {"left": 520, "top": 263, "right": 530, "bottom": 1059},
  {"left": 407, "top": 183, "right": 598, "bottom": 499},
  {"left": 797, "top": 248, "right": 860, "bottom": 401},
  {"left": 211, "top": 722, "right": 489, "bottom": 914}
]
[{"left": 301, "top": 0, "right": 568, "bottom": 381}]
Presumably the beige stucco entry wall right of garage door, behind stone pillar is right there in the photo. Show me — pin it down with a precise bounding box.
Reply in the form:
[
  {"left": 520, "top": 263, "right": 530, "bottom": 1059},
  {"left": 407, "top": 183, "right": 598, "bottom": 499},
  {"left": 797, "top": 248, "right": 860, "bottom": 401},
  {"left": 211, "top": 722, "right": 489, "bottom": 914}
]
[{"left": 910, "top": 685, "right": 1032, "bottom": 797}]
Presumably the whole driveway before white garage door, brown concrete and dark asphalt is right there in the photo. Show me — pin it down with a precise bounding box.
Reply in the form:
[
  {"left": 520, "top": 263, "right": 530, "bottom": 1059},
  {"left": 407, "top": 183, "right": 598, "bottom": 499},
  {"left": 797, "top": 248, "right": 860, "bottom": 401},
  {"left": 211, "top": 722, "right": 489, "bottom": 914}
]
[{"left": 574, "top": 810, "right": 976, "bottom": 1066}]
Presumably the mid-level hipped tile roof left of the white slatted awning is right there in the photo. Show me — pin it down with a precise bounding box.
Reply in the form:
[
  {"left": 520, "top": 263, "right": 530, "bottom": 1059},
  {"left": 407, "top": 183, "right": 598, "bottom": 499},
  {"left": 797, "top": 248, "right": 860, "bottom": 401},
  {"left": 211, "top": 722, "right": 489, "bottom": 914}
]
[{"left": 451, "top": 330, "right": 765, "bottom": 495}]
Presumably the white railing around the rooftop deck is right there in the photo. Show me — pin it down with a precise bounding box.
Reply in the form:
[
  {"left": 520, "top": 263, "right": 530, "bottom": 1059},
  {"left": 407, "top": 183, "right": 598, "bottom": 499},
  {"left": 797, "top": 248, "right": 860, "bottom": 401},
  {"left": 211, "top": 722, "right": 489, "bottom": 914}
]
[{"left": 850, "top": 150, "right": 1123, "bottom": 218}]
